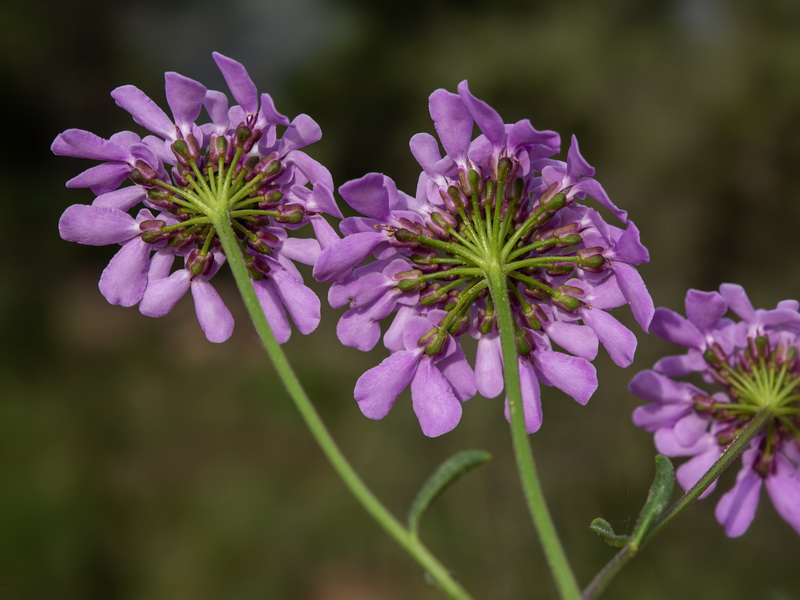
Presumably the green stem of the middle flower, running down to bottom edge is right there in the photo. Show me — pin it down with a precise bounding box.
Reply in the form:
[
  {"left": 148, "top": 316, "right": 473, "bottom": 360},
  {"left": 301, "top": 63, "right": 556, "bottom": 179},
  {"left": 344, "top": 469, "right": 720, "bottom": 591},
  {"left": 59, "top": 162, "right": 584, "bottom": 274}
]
[{"left": 486, "top": 265, "right": 581, "bottom": 600}]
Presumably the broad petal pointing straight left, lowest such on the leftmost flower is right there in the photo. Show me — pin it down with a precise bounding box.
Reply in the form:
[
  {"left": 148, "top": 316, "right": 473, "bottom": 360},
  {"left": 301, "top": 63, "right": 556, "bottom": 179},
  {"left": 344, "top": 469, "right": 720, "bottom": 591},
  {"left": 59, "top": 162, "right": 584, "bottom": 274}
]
[{"left": 58, "top": 204, "right": 141, "bottom": 246}]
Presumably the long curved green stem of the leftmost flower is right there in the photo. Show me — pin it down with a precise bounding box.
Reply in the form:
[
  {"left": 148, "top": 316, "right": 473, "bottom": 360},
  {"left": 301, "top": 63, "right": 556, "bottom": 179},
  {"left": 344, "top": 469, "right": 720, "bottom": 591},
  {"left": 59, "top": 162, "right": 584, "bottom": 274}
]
[{"left": 212, "top": 208, "right": 470, "bottom": 600}]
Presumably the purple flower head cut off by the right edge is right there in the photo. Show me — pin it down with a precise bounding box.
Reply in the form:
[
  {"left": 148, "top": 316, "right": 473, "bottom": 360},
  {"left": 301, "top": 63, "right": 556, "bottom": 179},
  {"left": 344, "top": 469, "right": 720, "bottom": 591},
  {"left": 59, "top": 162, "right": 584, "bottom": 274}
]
[{"left": 630, "top": 283, "right": 800, "bottom": 537}]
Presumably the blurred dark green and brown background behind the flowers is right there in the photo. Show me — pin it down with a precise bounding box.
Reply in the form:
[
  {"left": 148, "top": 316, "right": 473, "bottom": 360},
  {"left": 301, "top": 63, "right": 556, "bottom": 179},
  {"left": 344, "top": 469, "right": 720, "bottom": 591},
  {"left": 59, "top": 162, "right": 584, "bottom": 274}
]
[{"left": 0, "top": 0, "right": 800, "bottom": 600}]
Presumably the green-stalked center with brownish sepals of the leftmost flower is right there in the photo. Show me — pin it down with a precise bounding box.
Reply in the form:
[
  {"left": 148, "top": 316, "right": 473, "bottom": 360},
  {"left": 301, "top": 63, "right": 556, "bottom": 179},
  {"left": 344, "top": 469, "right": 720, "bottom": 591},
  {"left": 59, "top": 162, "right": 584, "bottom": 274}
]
[{"left": 131, "top": 123, "right": 305, "bottom": 279}]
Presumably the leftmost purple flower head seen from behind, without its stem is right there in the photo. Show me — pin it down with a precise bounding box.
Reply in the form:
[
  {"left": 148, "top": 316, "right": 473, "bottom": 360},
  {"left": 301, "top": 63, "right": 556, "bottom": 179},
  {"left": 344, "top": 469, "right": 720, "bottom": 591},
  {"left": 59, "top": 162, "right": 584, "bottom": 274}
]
[{"left": 52, "top": 53, "right": 341, "bottom": 342}]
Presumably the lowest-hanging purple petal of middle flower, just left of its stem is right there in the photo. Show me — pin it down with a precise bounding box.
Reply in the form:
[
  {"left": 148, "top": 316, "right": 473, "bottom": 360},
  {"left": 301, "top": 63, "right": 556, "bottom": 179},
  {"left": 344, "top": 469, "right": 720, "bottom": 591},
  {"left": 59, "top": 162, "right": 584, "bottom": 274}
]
[{"left": 411, "top": 357, "right": 461, "bottom": 437}]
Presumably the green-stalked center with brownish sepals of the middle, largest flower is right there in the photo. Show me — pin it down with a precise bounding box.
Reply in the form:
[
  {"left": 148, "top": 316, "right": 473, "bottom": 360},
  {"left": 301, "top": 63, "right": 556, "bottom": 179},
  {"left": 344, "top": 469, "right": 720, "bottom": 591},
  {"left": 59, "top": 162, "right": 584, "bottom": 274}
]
[{"left": 391, "top": 157, "right": 607, "bottom": 355}]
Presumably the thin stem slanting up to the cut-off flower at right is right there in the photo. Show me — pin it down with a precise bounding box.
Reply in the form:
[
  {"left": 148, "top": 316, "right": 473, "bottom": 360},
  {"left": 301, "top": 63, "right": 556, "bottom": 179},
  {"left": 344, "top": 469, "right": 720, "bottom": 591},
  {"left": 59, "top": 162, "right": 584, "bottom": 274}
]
[{"left": 583, "top": 409, "right": 774, "bottom": 600}]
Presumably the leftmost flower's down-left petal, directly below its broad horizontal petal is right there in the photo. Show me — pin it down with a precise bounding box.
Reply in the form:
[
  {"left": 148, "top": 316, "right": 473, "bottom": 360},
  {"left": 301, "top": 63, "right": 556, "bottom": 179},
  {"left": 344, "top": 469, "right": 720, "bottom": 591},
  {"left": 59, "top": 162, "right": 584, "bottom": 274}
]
[{"left": 99, "top": 238, "right": 153, "bottom": 306}]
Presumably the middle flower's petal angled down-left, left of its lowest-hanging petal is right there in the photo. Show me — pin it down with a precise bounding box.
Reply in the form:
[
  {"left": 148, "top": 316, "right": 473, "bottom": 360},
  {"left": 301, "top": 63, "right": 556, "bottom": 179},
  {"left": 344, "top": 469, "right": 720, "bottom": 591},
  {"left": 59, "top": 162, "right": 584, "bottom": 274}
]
[{"left": 354, "top": 352, "right": 419, "bottom": 419}]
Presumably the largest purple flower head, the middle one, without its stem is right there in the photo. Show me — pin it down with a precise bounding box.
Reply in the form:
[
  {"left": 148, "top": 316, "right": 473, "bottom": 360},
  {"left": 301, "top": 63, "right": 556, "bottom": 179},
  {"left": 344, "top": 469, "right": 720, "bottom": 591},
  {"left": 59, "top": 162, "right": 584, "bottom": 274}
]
[{"left": 314, "top": 82, "right": 653, "bottom": 436}]
